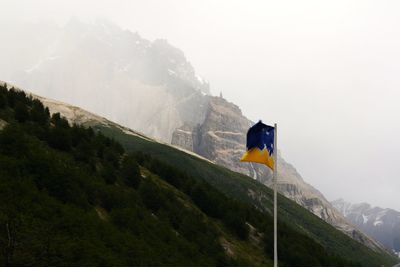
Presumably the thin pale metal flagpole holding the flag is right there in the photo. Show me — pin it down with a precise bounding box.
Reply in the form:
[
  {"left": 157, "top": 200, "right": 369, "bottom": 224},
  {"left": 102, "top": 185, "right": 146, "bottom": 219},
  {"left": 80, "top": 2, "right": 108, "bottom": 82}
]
[{"left": 272, "top": 123, "right": 278, "bottom": 267}]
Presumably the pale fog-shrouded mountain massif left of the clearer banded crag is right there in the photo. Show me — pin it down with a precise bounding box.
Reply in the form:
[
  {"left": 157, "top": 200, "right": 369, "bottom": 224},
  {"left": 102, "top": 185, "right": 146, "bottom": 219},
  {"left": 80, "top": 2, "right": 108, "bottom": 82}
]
[{"left": 0, "top": 19, "right": 209, "bottom": 141}]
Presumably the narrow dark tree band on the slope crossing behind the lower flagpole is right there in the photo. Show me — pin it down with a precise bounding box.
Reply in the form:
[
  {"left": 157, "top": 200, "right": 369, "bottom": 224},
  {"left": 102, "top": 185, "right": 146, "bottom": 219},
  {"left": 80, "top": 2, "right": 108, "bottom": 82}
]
[{"left": 137, "top": 153, "right": 357, "bottom": 266}]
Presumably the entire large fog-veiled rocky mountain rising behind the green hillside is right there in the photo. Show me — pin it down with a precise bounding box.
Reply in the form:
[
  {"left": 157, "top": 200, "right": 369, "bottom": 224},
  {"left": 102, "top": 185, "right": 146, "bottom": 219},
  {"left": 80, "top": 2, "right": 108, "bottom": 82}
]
[{"left": 0, "top": 19, "right": 388, "bottom": 251}]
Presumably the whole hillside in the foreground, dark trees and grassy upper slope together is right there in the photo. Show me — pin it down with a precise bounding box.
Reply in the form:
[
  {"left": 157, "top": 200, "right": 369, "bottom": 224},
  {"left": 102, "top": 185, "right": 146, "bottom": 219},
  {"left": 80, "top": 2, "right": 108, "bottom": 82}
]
[{"left": 0, "top": 83, "right": 395, "bottom": 266}]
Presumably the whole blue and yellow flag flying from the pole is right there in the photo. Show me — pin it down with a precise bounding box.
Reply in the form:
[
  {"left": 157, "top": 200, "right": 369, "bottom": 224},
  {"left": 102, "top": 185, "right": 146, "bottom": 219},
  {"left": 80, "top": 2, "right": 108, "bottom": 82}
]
[{"left": 240, "top": 121, "right": 275, "bottom": 170}]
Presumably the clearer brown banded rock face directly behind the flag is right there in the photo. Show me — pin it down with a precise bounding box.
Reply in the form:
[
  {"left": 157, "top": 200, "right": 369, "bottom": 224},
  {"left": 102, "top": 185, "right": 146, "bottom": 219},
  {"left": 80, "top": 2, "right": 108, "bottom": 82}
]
[{"left": 171, "top": 96, "right": 381, "bottom": 252}]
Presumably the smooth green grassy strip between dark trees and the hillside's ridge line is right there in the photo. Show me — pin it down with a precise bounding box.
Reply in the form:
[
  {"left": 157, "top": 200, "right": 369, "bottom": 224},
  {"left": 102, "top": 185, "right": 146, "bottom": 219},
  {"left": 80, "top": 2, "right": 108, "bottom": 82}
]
[{"left": 97, "top": 126, "right": 396, "bottom": 266}]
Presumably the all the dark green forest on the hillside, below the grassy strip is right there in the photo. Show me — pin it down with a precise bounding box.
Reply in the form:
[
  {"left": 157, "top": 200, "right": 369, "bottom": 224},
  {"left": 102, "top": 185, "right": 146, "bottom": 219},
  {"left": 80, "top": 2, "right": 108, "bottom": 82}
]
[{"left": 0, "top": 86, "right": 394, "bottom": 267}]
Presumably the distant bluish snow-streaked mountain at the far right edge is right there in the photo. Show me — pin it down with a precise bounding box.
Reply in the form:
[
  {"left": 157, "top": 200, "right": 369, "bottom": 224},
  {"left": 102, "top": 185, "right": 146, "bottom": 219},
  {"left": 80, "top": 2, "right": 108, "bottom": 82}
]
[{"left": 332, "top": 199, "right": 400, "bottom": 256}]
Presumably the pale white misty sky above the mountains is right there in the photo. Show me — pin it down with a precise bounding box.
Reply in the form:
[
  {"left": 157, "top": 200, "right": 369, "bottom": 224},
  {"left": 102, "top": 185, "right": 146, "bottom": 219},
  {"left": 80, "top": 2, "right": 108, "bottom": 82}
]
[{"left": 0, "top": 0, "right": 400, "bottom": 210}]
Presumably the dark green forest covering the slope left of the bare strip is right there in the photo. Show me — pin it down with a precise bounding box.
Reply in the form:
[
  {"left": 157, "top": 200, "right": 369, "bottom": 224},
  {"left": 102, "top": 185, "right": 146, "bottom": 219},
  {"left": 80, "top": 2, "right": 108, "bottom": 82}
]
[{"left": 0, "top": 88, "right": 241, "bottom": 266}]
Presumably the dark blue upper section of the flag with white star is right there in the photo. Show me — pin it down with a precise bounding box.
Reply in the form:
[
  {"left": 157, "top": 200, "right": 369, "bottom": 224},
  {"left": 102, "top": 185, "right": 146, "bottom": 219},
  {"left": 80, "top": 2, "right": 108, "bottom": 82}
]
[{"left": 246, "top": 121, "right": 274, "bottom": 156}]
